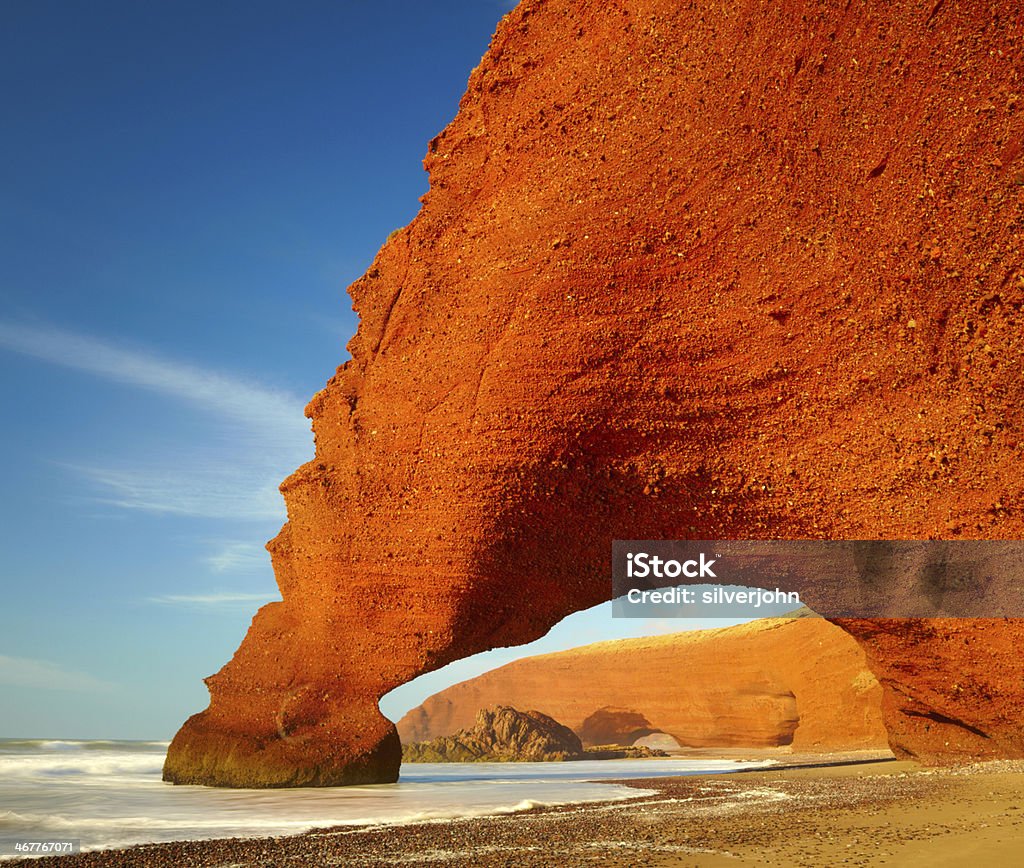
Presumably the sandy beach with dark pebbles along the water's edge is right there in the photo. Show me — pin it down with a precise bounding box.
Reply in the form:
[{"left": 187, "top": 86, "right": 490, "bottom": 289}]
[{"left": 14, "top": 754, "right": 1024, "bottom": 868}]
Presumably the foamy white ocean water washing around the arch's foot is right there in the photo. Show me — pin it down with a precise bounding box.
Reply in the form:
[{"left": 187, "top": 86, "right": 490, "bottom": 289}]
[{"left": 0, "top": 739, "right": 766, "bottom": 850}]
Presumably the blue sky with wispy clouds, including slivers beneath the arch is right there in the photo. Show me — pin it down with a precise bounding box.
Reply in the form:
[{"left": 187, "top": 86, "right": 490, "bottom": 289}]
[{"left": 0, "top": 0, "right": 753, "bottom": 738}]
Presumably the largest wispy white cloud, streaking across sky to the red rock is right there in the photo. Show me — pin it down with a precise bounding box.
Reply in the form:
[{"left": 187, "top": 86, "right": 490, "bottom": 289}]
[{"left": 0, "top": 320, "right": 312, "bottom": 520}]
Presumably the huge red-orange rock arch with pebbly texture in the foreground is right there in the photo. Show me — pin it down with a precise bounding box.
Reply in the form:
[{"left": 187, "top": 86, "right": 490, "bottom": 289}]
[{"left": 165, "top": 0, "right": 1024, "bottom": 786}]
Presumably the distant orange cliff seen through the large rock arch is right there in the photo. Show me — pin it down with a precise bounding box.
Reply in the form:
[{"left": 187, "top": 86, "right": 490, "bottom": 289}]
[{"left": 398, "top": 617, "right": 887, "bottom": 750}]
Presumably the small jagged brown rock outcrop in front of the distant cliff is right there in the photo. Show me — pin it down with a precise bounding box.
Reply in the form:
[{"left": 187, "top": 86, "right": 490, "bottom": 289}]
[{"left": 401, "top": 705, "right": 583, "bottom": 763}]
